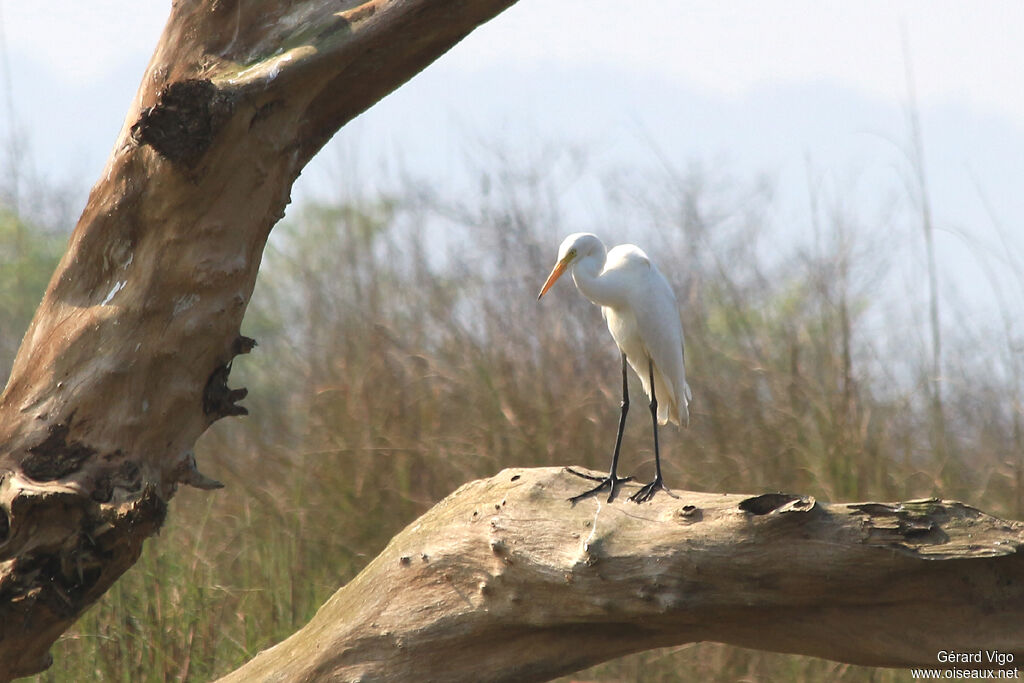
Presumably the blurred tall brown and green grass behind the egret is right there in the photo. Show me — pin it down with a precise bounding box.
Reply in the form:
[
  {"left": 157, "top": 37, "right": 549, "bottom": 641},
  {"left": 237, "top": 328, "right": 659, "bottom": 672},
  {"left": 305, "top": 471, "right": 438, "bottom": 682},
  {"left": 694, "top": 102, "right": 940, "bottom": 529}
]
[{"left": 0, "top": 143, "right": 1024, "bottom": 682}]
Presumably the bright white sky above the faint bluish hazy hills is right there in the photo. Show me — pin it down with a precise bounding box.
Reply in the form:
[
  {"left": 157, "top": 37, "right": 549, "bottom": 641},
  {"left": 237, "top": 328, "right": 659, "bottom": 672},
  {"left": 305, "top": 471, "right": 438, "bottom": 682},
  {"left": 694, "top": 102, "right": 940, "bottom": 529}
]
[{"left": 6, "top": 0, "right": 1024, "bottom": 122}]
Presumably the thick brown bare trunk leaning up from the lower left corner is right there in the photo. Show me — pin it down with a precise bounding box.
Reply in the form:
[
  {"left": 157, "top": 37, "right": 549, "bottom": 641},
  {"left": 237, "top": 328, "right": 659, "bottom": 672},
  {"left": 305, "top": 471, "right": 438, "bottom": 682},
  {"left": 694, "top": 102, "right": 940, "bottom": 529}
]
[{"left": 0, "top": 0, "right": 514, "bottom": 680}]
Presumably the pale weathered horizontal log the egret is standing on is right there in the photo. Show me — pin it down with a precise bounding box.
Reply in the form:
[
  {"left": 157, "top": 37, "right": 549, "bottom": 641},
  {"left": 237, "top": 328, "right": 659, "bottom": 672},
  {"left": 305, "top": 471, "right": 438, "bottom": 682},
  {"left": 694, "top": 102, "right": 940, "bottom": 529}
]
[{"left": 221, "top": 468, "right": 1024, "bottom": 682}]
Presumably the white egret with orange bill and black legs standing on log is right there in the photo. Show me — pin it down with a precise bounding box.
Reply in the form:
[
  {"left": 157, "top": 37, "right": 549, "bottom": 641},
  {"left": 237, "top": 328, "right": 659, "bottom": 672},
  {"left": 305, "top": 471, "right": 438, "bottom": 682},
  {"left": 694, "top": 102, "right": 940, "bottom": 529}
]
[{"left": 537, "top": 232, "right": 690, "bottom": 503}]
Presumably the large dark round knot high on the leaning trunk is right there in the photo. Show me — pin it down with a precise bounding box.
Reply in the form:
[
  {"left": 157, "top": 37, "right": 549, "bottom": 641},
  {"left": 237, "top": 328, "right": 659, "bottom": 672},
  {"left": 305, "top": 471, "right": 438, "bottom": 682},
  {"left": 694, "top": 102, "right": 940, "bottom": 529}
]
[{"left": 131, "top": 79, "right": 234, "bottom": 168}]
